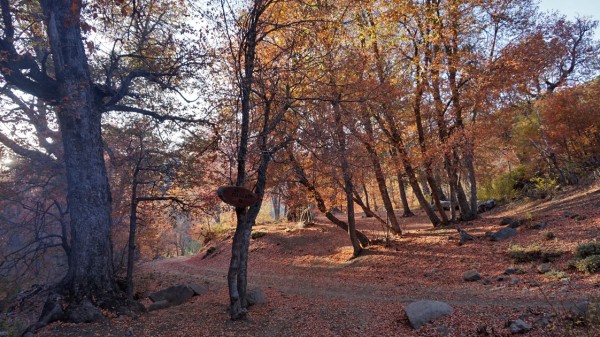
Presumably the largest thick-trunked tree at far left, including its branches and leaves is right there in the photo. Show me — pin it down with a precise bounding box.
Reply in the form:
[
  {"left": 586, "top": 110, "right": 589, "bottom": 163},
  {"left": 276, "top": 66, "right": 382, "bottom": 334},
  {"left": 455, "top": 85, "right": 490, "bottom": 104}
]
[{"left": 0, "top": 0, "right": 210, "bottom": 317}]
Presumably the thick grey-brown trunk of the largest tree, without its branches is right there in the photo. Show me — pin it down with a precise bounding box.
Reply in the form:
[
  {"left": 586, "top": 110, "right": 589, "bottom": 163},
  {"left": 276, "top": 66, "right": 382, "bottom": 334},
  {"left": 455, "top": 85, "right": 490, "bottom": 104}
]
[{"left": 41, "top": 0, "right": 117, "bottom": 306}]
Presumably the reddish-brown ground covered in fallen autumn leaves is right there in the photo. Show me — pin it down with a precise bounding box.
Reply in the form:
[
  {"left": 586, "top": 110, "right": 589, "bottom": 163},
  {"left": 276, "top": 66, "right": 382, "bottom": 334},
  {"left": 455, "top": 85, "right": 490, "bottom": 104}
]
[{"left": 37, "top": 186, "right": 600, "bottom": 337}]
